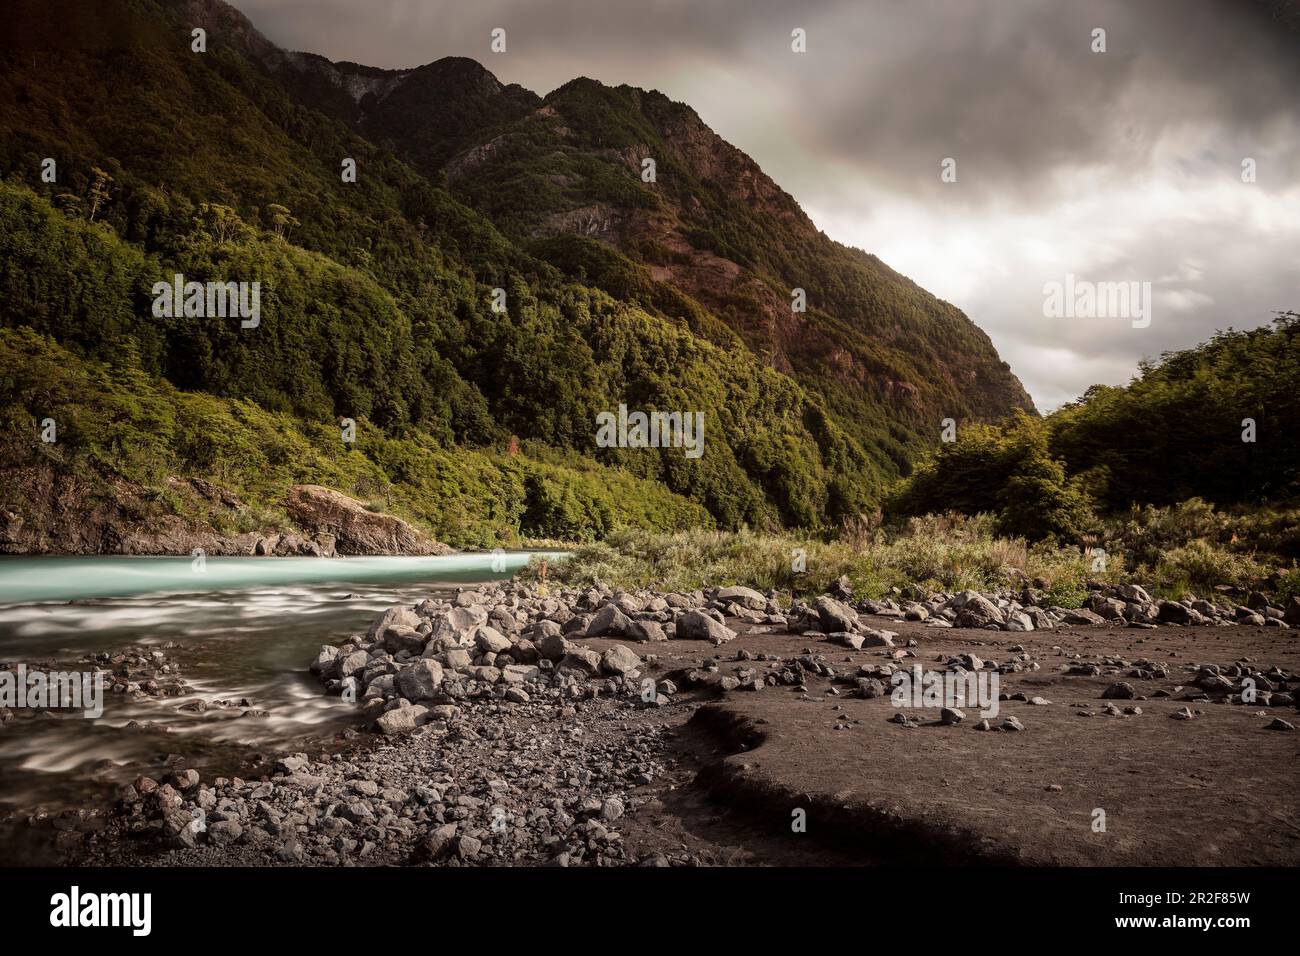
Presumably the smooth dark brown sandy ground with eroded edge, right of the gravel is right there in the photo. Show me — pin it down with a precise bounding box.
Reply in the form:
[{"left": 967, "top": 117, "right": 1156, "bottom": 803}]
[{"left": 603, "top": 619, "right": 1300, "bottom": 866}]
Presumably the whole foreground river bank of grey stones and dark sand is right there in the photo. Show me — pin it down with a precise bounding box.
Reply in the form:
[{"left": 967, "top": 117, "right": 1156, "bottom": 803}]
[{"left": 22, "top": 572, "right": 1300, "bottom": 865}]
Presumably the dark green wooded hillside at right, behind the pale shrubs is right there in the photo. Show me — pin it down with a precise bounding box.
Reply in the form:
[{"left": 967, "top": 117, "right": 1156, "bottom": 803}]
[{"left": 889, "top": 312, "right": 1300, "bottom": 538}]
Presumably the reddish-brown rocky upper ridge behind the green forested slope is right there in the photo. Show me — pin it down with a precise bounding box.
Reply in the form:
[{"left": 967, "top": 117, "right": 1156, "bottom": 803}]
[{"left": 202, "top": 0, "right": 1034, "bottom": 431}]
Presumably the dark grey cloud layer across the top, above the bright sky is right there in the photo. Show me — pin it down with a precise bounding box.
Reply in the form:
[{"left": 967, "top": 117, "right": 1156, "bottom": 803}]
[{"left": 237, "top": 0, "right": 1300, "bottom": 203}]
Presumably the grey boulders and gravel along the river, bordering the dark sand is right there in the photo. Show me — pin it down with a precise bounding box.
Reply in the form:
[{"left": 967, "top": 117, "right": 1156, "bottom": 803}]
[{"left": 38, "top": 574, "right": 1300, "bottom": 865}]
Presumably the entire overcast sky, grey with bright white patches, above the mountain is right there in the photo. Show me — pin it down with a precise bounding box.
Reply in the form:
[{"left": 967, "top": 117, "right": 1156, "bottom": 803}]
[{"left": 234, "top": 0, "right": 1300, "bottom": 410}]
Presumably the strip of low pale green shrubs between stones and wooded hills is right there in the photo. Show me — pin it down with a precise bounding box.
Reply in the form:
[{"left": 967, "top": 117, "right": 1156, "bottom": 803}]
[{"left": 535, "top": 507, "right": 1300, "bottom": 607}]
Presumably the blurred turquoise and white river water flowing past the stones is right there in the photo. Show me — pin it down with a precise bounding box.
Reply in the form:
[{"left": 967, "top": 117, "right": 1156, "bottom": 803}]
[{"left": 0, "top": 553, "right": 553, "bottom": 862}]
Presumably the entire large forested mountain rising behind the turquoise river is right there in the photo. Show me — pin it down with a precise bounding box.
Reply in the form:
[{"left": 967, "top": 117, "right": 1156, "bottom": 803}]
[{"left": 0, "top": 0, "right": 1031, "bottom": 544}]
